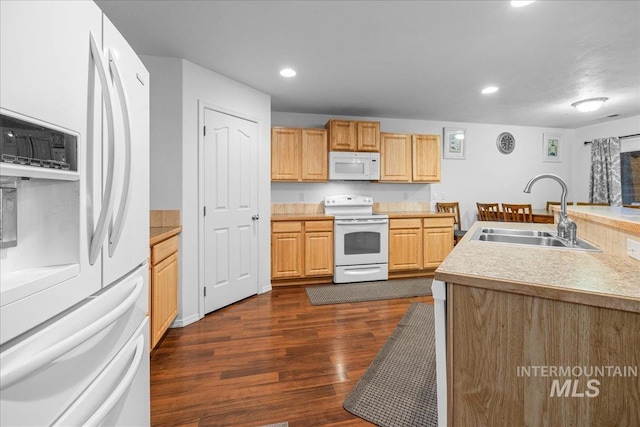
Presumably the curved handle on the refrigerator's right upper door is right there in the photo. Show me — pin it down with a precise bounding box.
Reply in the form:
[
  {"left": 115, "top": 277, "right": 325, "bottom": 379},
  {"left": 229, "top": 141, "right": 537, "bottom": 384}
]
[{"left": 109, "top": 51, "right": 131, "bottom": 257}]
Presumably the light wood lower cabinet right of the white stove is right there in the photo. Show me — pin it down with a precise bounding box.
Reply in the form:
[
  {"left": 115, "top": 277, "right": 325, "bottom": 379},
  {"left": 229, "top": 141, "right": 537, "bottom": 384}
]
[{"left": 389, "top": 217, "right": 453, "bottom": 276}]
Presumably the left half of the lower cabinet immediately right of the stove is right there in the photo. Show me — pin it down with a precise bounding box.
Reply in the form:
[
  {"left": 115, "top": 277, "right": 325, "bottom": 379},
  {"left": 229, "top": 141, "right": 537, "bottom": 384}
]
[{"left": 389, "top": 218, "right": 422, "bottom": 271}]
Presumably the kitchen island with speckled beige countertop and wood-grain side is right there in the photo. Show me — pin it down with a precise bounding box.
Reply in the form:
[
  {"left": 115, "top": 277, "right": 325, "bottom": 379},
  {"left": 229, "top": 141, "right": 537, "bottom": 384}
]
[{"left": 435, "top": 208, "right": 640, "bottom": 426}]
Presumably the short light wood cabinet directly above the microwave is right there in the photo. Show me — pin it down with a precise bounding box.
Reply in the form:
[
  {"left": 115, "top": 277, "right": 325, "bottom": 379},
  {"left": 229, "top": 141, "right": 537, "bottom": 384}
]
[{"left": 325, "top": 119, "right": 380, "bottom": 153}]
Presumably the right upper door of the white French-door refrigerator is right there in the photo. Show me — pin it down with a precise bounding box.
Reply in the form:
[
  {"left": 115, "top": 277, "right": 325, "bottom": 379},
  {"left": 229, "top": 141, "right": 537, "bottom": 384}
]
[{"left": 102, "top": 15, "right": 149, "bottom": 286}]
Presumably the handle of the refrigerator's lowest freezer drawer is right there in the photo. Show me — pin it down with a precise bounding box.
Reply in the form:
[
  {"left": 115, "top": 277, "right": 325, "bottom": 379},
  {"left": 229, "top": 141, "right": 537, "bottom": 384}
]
[{"left": 53, "top": 335, "right": 145, "bottom": 426}]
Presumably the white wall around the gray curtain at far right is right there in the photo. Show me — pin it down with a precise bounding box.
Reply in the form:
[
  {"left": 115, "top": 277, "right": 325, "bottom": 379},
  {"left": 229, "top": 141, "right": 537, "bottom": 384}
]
[{"left": 573, "top": 116, "right": 640, "bottom": 201}]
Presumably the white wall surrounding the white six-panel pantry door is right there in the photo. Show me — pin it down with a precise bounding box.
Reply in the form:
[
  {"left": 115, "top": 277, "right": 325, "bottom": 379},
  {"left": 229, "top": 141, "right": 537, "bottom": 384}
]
[{"left": 142, "top": 56, "right": 271, "bottom": 326}]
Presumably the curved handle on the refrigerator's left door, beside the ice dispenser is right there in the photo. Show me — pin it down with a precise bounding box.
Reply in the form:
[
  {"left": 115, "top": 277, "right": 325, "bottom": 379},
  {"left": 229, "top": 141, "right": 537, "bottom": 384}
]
[{"left": 88, "top": 34, "right": 116, "bottom": 265}]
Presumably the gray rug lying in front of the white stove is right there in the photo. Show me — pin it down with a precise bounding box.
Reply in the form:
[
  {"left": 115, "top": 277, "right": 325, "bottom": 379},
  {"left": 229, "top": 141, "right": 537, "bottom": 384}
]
[{"left": 305, "top": 277, "right": 433, "bottom": 305}]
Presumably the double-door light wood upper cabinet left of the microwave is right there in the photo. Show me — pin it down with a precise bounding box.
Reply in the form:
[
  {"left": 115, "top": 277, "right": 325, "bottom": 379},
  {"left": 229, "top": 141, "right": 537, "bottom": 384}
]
[{"left": 271, "top": 126, "right": 328, "bottom": 182}]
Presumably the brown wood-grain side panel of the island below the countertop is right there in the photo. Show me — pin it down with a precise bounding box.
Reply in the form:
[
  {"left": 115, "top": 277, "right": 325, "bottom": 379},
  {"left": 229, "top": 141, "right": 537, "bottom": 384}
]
[{"left": 447, "top": 284, "right": 640, "bottom": 426}]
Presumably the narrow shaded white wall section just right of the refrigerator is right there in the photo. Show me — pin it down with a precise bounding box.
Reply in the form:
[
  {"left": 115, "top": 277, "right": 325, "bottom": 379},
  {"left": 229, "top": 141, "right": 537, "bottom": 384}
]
[{"left": 140, "top": 55, "right": 182, "bottom": 210}]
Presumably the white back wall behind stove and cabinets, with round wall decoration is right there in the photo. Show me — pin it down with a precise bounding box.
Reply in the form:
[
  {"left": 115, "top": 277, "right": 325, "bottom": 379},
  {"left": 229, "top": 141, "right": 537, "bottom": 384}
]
[{"left": 271, "top": 112, "right": 574, "bottom": 228}]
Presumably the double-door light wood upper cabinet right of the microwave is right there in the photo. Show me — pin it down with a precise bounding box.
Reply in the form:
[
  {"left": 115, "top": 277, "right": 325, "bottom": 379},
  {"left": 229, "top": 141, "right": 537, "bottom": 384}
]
[{"left": 380, "top": 132, "right": 441, "bottom": 182}]
